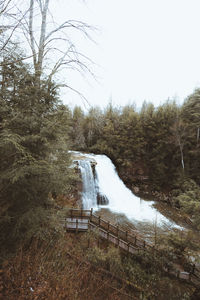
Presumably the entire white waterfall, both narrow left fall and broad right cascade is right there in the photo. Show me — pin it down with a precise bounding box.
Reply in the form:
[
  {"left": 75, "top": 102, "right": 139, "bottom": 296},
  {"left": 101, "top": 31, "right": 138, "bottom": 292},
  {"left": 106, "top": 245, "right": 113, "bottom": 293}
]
[{"left": 72, "top": 151, "right": 179, "bottom": 227}]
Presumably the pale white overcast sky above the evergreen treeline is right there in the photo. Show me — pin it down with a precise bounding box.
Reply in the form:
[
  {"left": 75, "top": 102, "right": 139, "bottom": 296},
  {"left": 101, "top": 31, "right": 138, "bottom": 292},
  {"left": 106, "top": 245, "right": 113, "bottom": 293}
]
[{"left": 51, "top": 0, "right": 200, "bottom": 107}]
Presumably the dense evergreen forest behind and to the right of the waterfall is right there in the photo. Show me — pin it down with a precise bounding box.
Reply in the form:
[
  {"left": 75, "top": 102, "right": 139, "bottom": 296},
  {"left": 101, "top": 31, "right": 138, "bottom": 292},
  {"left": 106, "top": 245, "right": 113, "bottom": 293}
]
[{"left": 71, "top": 96, "right": 200, "bottom": 227}]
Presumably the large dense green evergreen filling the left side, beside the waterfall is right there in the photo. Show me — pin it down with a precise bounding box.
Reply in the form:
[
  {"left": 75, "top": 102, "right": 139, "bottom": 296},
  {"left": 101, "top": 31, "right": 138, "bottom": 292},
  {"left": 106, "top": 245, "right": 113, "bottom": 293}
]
[{"left": 0, "top": 51, "right": 73, "bottom": 257}]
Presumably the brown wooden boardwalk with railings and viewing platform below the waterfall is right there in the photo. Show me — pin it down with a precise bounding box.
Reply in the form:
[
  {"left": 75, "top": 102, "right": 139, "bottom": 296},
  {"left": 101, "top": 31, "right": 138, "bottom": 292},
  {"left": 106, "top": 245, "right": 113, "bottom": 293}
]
[{"left": 65, "top": 209, "right": 200, "bottom": 283}]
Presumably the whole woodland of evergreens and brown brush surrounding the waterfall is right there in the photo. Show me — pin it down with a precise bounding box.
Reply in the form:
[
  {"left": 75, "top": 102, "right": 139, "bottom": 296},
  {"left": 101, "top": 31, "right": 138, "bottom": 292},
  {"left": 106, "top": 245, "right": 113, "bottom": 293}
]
[{"left": 0, "top": 1, "right": 200, "bottom": 300}]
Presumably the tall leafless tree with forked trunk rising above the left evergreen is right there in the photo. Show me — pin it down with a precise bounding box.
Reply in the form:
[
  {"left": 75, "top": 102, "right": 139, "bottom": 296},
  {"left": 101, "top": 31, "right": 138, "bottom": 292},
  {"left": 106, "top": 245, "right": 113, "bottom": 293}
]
[{"left": 21, "top": 0, "right": 94, "bottom": 92}]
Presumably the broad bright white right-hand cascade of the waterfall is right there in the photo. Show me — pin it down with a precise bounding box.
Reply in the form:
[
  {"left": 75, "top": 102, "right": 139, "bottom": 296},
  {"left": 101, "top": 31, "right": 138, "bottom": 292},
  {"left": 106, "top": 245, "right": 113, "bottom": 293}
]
[{"left": 95, "top": 155, "right": 168, "bottom": 223}]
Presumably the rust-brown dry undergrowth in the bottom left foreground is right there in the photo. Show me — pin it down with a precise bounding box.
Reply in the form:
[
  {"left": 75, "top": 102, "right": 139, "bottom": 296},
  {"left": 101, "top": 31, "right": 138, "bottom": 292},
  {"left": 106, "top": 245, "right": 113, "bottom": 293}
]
[{"left": 0, "top": 235, "right": 138, "bottom": 300}]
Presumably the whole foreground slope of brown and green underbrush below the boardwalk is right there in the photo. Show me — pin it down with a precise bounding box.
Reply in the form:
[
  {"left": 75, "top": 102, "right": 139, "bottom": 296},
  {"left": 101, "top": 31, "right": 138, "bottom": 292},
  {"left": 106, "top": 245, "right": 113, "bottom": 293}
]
[{"left": 0, "top": 226, "right": 195, "bottom": 300}]
